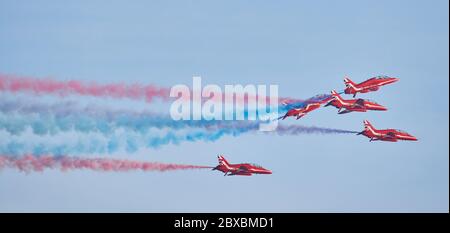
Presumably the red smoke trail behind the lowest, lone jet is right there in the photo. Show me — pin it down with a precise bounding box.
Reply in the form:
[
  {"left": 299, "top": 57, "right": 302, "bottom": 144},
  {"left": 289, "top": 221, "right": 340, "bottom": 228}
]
[{"left": 0, "top": 155, "right": 212, "bottom": 172}]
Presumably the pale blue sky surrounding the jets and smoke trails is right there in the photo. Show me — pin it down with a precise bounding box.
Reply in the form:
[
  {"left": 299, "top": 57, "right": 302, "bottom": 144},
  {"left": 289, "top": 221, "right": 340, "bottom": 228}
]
[{"left": 0, "top": 0, "right": 449, "bottom": 212}]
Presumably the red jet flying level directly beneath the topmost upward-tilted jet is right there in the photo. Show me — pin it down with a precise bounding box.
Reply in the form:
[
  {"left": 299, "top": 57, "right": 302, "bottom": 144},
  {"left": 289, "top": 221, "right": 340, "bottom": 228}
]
[{"left": 325, "top": 91, "right": 387, "bottom": 114}]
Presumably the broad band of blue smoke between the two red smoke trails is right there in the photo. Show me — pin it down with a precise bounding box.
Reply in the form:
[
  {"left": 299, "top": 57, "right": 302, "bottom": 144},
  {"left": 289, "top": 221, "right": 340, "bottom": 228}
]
[{"left": 0, "top": 94, "right": 355, "bottom": 155}]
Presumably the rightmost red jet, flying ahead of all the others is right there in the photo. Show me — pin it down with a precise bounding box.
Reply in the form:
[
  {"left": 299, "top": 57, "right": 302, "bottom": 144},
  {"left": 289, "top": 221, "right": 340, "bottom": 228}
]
[{"left": 358, "top": 120, "right": 417, "bottom": 142}]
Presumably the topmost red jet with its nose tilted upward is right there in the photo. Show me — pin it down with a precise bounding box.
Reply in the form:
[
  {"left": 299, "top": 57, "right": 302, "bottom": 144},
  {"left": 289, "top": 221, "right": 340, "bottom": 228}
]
[{"left": 344, "top": 76, "right": 399, "bottom": 98}]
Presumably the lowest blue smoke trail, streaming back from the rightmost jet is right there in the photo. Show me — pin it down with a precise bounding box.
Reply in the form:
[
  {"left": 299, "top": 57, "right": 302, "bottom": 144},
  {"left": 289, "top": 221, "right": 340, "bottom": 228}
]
[{"left": 0, "top": 122, "right": 356, "bottom": 155}]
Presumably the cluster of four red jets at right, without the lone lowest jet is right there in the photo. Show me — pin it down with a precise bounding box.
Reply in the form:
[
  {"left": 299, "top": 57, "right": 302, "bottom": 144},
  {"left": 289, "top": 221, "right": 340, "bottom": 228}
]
[{"left": 278, "top": 76, "right": 417, "bottom": 142}]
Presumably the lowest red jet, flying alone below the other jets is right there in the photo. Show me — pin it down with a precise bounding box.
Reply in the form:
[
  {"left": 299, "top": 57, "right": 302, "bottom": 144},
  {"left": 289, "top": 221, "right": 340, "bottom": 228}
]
[{"left": 212, "top": 155, "right": 272, "bottom": 176}]
